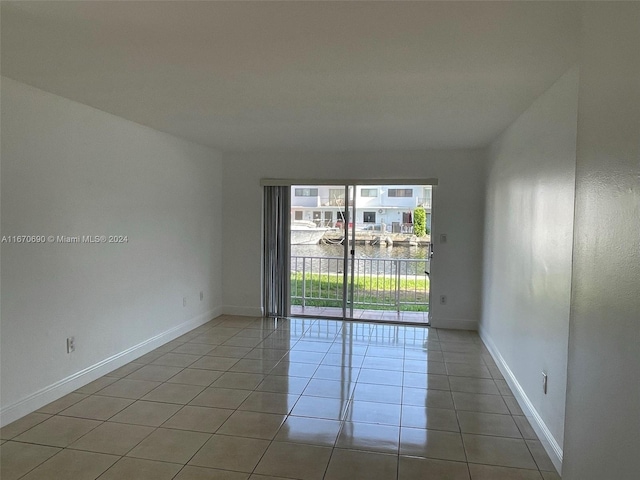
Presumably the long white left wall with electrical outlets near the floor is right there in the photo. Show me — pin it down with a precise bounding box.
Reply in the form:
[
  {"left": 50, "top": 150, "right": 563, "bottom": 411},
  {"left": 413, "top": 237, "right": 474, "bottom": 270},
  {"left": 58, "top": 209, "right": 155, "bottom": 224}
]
[{"left": 1, "top": 78, "right": 222, "bottom": 424}]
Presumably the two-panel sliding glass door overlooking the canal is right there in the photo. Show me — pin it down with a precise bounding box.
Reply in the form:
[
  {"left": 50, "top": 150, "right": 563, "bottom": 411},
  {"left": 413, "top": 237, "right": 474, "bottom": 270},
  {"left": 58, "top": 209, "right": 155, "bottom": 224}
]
[{"left": 290, "top": 183, "right": 432, "bottom": 323}]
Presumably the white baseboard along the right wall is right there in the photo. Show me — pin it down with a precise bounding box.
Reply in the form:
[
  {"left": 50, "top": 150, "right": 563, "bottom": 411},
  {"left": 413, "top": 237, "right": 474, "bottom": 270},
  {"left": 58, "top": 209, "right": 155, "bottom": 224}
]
[{"left": 479, "top": 329, "right": 563, "bottom": 473}]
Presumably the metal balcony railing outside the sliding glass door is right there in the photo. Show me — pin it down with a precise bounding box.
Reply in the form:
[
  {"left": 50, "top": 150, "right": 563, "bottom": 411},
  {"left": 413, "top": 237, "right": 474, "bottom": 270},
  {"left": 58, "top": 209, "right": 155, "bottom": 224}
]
[{"left": 291, "top": 256, "right": 430, "bottom": 312}]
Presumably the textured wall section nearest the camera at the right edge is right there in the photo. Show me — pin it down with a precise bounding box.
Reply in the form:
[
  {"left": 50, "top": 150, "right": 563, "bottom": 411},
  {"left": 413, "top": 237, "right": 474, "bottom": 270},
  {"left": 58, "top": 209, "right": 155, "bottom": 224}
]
[{"left": 562, "top": 2, "right": 640, "bottom": 480}]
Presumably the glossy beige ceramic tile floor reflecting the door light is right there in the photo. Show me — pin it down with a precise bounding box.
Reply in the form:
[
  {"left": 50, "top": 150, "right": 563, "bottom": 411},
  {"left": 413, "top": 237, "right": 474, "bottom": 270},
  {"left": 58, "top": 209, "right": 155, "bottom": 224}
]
[{"left": 0, "top": 316, "right": 560, "bottom": 480}]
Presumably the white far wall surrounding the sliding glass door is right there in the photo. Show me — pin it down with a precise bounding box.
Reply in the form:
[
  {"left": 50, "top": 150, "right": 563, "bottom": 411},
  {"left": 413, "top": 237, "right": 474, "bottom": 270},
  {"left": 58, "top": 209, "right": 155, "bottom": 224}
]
[{"left": 223, "top": 151, "right": 484, "bottom": 328}]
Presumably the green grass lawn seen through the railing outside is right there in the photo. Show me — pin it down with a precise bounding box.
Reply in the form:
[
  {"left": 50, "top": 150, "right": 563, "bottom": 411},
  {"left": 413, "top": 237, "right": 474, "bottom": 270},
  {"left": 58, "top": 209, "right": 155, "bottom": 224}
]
[{"left": 291, "top": 272, "right": 429, "bottom": 312}]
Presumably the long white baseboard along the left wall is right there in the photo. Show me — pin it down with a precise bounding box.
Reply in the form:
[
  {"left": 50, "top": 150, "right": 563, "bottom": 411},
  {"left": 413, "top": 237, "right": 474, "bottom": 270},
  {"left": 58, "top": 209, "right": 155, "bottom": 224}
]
[{"left": 0, "top": 307, "right": 222, "bottom": 426}]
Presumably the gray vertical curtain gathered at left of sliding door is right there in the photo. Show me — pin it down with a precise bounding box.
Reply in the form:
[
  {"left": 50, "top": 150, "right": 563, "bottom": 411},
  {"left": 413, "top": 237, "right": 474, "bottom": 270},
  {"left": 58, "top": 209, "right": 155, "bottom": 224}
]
[{"left": 263, "top": 186, "right": 291, "bottom": 317}]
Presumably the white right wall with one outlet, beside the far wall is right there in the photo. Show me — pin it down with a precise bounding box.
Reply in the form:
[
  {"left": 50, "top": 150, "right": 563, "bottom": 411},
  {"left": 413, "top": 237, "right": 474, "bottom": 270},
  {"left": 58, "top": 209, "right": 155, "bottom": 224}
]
[{"left": 480, "top": 67, "right": 578, "bottom": 465}]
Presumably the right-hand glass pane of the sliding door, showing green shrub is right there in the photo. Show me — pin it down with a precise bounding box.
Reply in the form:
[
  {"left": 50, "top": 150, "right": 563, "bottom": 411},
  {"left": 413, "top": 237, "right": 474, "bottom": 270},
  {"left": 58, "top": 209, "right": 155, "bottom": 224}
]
[{"left": 348, "top": 185, "right": 431, "bottom": 323}]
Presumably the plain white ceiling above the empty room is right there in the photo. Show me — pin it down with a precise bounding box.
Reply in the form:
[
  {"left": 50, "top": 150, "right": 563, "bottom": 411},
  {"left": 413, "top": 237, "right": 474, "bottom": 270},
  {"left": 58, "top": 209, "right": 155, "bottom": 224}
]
[{"left": 1, "top": 1, "right": 580, "bottom": 151}]
